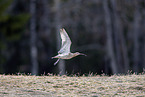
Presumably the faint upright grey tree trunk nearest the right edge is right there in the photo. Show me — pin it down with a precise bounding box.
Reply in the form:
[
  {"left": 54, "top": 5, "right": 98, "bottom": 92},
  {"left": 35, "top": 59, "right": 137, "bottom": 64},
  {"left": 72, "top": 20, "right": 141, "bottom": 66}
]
[{"left": 133, "top": 1, "right": 141, "bottom": 72}]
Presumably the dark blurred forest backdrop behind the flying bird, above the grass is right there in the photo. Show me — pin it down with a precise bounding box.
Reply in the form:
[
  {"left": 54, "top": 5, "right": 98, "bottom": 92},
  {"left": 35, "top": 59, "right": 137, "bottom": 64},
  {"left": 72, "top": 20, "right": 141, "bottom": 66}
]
[{"left": 0, "top": 0, "right": 145, "bottom": 75}]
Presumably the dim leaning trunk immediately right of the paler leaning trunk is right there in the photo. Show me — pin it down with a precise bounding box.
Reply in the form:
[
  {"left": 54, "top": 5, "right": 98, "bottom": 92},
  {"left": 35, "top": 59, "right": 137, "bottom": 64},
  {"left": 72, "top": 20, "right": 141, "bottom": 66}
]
[{"left": 111, "top": 0, "right": 129, "bottom": 73}]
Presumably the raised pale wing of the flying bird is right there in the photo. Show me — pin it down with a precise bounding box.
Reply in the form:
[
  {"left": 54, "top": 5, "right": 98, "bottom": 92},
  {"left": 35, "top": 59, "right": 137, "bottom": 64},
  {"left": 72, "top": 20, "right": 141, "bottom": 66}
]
[{"left": 58, "top": 28, "right": 71, "bottom": 54}]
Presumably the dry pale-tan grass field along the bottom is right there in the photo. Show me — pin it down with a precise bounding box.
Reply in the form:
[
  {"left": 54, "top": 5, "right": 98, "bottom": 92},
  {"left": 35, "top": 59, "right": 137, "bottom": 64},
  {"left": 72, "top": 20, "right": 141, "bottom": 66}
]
[{"left": 0, "top": 74, "right": 145, "bottom": 97}]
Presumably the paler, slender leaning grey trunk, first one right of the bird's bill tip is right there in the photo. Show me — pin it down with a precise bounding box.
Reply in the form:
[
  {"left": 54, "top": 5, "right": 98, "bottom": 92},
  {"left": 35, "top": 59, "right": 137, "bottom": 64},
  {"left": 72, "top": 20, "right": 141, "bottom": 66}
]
[{"left": 103, "top": 0, "right": 118, "bottom": 74}]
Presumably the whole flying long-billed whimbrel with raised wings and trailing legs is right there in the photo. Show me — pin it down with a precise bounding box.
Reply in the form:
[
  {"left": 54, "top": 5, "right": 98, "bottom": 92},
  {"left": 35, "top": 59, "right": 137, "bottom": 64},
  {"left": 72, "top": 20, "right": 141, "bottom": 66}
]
[{"left": 52, "top": 29, "right": 86, "bottom": 65}]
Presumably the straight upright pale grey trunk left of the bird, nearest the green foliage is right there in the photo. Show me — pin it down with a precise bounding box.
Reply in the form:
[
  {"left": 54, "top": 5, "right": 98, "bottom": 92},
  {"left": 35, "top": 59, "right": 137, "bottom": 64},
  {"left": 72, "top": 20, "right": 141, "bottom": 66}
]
[{"left": 30, "top": 0, "right": 38, "bottom": 75}]
